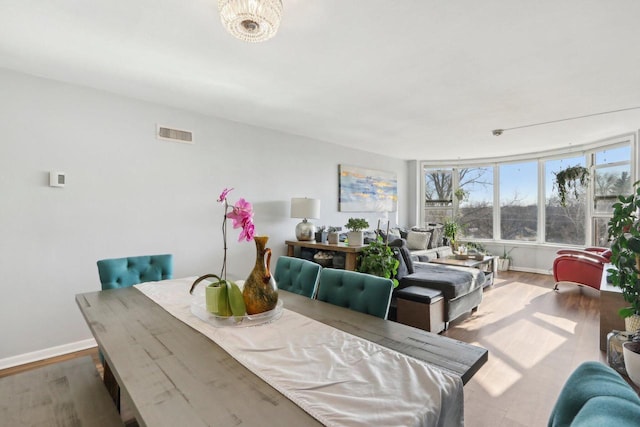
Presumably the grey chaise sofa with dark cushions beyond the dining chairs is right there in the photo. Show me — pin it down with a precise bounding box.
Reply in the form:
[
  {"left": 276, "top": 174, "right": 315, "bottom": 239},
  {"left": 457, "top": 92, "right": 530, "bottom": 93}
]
[{"left": 389, "top": 238, "right": 486, "bottom": 330}]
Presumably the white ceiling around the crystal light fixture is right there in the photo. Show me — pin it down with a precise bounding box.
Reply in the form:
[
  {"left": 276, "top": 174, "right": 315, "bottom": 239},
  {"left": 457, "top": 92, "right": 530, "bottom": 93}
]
[{"left": 0, "top": 0, "right": 640, "bottom": 160}]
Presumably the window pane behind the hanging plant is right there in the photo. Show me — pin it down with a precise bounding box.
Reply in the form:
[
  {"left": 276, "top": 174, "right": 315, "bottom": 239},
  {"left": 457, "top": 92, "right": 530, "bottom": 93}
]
[{"left": 544, "top": 156, "right": 587, "bottom": 245}]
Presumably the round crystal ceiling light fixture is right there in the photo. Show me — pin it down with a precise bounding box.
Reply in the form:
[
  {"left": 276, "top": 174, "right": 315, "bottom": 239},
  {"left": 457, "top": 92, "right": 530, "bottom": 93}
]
[{"left": 218, "top": 0, "right": 282, "bottom": 43}]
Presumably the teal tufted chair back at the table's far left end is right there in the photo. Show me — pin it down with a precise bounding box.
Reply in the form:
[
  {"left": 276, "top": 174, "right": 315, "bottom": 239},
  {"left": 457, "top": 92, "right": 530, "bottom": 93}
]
[{"left": 98, "top": 254, "right": 173, "bottom": 290}]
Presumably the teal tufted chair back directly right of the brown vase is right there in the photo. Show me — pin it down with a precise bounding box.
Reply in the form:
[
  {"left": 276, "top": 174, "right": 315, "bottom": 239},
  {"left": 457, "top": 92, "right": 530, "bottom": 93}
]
[{"left": 274, "top": 256, "right": 322, "bottom": 298}]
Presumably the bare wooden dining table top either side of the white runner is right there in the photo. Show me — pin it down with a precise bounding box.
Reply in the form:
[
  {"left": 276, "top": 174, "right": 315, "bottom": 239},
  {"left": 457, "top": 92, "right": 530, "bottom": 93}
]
[{"left": 76, "top": 287, "right": 488, "bottom": 426}]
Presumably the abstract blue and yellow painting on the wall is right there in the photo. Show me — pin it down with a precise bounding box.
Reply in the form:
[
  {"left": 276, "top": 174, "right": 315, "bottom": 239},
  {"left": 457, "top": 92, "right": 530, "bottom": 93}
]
[{"left": 338, "top": 165, "right": 398, "bottom": 212}]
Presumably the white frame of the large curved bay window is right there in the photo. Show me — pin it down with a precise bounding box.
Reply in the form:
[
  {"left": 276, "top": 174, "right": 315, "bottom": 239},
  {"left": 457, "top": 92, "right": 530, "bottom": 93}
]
[{"left": 418, "top": 133, "right": 640, "bottom": 246}]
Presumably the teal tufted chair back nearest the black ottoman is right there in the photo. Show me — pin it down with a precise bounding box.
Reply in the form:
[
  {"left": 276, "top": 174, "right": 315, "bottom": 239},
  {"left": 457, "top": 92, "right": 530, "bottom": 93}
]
[{"left": 317, "top": 268, "right": 393, "bottom": 319}]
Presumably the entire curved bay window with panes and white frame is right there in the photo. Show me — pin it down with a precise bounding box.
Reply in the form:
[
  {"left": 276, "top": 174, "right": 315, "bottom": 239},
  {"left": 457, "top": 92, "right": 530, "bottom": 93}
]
[{"left": 420, "top": 134, "right": 637, "bottom": 247}]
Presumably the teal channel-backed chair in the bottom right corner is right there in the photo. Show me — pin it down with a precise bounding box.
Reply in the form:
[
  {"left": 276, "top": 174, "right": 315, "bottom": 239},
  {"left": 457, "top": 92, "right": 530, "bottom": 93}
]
[{"left": 548, "top": 362, "right": 640, "bottom": 427}]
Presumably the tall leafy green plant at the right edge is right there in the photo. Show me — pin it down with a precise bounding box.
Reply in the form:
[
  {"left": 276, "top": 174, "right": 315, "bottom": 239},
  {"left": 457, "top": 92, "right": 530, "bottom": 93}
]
[{"left": 607, "top": 181, "right": 640, "bottom": 318}]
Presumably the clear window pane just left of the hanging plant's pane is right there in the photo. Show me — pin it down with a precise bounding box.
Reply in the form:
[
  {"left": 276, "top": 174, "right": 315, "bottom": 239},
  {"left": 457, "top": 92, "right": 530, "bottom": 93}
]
[{"left": 500, "top": 162, "right": 538, "bottom": 241}]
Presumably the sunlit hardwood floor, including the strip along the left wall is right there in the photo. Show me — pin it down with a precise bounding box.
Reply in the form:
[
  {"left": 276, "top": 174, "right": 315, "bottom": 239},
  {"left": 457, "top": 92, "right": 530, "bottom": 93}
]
[{"left": 0, "top": 272, "right": 606, "bottom": 427}]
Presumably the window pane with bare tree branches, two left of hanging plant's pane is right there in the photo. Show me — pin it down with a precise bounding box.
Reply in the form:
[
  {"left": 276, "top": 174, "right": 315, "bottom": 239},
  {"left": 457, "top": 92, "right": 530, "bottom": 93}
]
[{"left": 456, "top": 167, "right": 493, "bottom": 239}]
